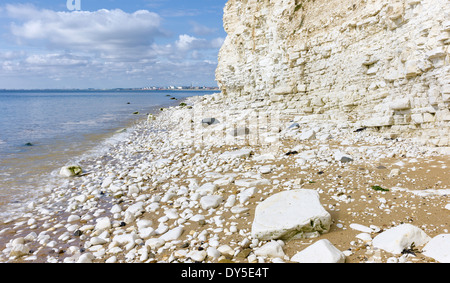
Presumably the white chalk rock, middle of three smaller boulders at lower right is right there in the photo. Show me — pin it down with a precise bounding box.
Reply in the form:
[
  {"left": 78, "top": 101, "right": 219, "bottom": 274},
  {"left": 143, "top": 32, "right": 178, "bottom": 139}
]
[{"left": 372, "top": 224, "right": 431, "bottom": 254}]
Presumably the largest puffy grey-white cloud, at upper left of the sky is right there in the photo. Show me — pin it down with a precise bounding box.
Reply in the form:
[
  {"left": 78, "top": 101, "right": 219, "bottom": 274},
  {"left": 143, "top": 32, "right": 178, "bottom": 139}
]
[{"left": 6, "top": 5, "right": 163, "bottom": 56}]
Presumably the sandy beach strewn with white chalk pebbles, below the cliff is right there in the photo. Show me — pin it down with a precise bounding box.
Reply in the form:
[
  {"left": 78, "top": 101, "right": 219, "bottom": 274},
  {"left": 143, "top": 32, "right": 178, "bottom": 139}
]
[{"left": 0, "top": 93, "right": 450, "bottom": 263}]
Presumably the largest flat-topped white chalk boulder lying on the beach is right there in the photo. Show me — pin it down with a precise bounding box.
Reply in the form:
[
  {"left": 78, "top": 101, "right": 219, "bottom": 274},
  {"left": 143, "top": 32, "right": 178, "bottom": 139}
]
[{"left": 252, "top": 189, "right": 331, "bottom": 240}]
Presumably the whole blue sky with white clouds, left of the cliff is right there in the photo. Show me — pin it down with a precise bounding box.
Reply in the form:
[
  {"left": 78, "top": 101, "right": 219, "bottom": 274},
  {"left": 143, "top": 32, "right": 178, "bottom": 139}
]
[{"left": 0, "top": 0, "right": 227, "bottom": 89}]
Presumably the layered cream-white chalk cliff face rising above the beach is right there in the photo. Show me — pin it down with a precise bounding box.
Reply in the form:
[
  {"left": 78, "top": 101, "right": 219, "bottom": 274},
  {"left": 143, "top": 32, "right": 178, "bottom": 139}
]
[{"left": 216, "top": 0, "right": 450, "bottom": 146}]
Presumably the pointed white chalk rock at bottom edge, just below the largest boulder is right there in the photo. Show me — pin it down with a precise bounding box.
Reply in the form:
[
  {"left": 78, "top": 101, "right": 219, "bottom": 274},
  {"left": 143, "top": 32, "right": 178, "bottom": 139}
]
[{"left": 291, "top": 239, "right": 345, "bottom": 263}]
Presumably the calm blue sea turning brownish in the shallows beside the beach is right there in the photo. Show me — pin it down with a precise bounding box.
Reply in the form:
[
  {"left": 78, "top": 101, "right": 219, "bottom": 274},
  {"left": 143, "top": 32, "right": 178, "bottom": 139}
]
[{"left": 0, "top": 91, "right": 214, "bottom": 219}]
